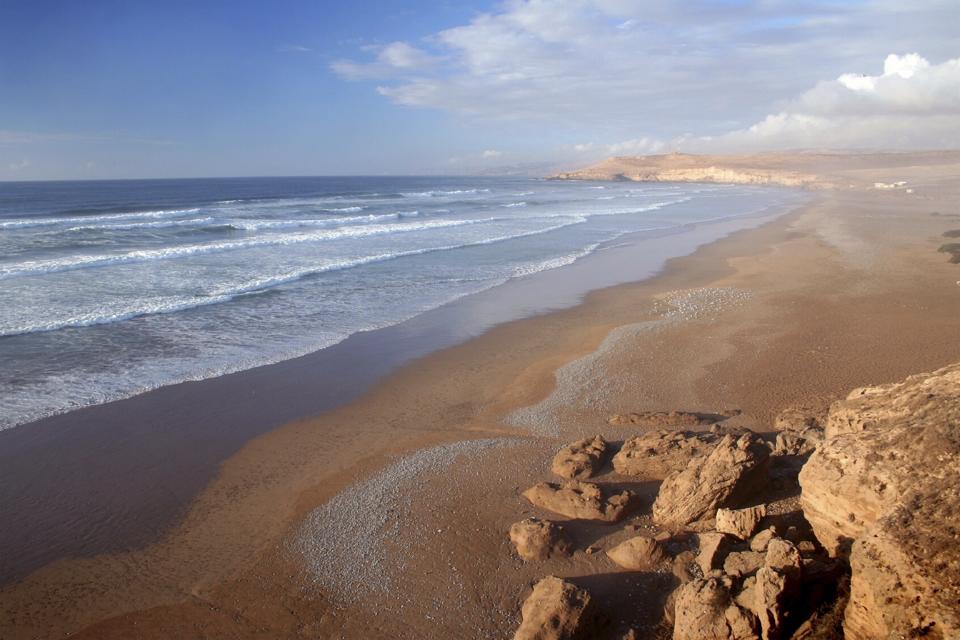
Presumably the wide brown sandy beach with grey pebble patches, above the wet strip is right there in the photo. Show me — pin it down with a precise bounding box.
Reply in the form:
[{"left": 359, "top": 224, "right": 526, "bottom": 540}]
[{"left": 0, "top": 155, "right": 960, "bottom": 639}]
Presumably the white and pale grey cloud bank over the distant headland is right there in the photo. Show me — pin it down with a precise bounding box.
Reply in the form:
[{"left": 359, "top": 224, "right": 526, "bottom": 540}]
[{"left": 332, "top": 0, "right": 960, "bottom": 154}]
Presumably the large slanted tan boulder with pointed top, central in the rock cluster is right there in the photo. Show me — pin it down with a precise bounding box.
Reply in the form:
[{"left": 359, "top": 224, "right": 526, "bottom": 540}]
[{"left": 653, "top": 434, "right": 770, "bottom": 527}]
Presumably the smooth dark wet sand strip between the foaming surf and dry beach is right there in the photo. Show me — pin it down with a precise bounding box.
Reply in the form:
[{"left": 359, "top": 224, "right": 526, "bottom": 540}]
[{"left": 0, "top": 195, "right": 797, "bottom": 586}]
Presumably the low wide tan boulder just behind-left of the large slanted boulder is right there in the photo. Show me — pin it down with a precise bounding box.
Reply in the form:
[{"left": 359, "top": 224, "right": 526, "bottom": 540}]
[{"left": 613, "top": 429, "right": 717, "bottom": 478}]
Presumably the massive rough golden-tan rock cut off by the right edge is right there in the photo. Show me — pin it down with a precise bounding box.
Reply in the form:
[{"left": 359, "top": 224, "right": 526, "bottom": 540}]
[{"left": 800, "top": 364, "right": 960, "bottom": 640}]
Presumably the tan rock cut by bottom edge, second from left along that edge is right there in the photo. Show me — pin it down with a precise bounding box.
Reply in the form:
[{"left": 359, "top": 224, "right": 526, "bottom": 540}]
[{"left": 673, "top": 577, "right": 757, "bottom": 640}]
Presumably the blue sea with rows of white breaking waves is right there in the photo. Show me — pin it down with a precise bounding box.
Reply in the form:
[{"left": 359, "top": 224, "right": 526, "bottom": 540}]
[{"left": 0, "top": 177, "right": 798, "bottom": 429}]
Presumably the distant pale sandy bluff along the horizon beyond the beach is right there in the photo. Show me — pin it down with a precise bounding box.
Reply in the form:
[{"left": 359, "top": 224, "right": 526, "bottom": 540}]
[{"left": 550, "top": 151, "right": 960, "bottom": 189}]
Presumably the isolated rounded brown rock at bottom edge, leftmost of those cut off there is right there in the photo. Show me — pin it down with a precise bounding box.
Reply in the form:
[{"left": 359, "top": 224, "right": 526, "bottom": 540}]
[{"left": 513, "top": 576, "right": 593, "bottom": 640}]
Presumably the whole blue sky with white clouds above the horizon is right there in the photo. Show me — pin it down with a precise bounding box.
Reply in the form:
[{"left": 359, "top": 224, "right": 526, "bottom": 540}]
[{"left": 0, "top": 0, "right": 960, "bottom": 180}]
